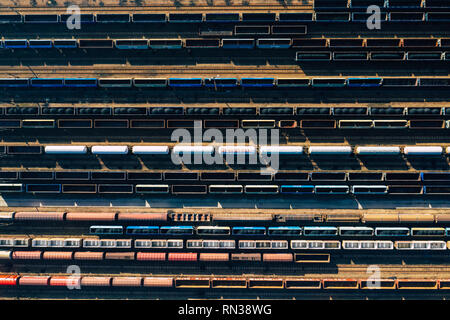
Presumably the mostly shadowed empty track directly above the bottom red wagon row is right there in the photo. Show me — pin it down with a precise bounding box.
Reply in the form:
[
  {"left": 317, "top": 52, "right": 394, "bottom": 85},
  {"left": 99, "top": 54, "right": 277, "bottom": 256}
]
[{"left": 4, "top": 262, "right": 450, "bottom": 279}]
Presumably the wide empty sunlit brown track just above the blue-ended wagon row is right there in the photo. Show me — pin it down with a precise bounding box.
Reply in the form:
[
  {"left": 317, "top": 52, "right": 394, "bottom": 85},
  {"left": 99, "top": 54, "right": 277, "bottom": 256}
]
[{"left": 0, "top": 64, "right": 450, "bottom": 78}]
